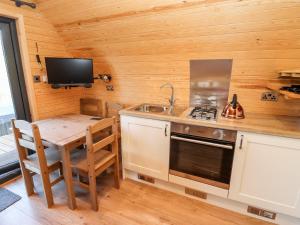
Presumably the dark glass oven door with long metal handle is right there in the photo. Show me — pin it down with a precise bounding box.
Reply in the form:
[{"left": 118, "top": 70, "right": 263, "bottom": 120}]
[{"left": 170, "top": 133, "right": 234, "bottom": 189}]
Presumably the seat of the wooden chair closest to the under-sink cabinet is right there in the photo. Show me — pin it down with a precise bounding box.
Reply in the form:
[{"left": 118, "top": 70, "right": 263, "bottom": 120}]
[{"left": 71, "top": 149, "right": 116, "bottom": 172}]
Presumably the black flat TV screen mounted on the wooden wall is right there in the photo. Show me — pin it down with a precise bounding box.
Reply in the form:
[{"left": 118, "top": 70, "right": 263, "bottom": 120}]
[{"left": 45, "top": 57, "right": 94, "bottom": 84}]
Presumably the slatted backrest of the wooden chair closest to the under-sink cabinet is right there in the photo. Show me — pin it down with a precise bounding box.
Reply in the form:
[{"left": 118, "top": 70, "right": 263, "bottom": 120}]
[{"left": 86, "top": 117, "right": 118, "bottom": 171}]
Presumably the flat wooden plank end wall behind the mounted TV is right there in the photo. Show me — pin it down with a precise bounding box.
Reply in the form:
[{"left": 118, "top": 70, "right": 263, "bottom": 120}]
[{"left": 0, "top": 0, "right": 83, "bottom": 119}]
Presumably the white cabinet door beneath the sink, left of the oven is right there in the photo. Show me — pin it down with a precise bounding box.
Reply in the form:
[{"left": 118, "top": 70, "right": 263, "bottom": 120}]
[{"left": 121, "top": 116, "right": 170, "bottom": 181}]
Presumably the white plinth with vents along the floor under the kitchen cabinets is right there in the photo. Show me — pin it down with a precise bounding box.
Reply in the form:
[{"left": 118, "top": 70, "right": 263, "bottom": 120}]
[{"left": 123, "top": 169, "right": 300, "bottom": 225}]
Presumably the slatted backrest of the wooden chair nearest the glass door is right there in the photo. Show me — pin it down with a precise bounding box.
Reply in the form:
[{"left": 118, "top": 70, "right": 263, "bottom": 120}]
[{"left": 12, "top": 119, "right": 47, "bottom": 171}]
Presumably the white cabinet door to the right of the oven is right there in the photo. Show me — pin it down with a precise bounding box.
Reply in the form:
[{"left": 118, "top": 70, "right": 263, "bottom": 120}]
[{"left": 229, "top": 132, "right": 300, "bottom": 217}]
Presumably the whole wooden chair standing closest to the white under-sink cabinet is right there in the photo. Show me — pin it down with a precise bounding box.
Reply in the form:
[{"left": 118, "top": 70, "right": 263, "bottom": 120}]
[{"left": 71, "top": 117, "right": 120, "bottom": 211}]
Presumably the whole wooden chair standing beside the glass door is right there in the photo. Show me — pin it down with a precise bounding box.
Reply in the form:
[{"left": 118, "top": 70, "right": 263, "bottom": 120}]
[{"left": 12, "top": 120, "right": 64, "bottom": 208}]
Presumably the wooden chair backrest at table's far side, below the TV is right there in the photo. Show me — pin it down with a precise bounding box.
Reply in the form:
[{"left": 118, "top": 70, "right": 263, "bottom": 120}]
[{"left": 80, "top": 98, "right": 105, "bottom": 117}]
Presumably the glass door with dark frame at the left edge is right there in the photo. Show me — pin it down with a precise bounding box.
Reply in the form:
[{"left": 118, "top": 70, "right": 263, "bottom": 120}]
[{"left": 0, "top": 17, "right": 30, "bottom": 183}]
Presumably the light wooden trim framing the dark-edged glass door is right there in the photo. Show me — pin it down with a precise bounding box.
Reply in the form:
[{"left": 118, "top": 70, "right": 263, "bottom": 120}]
[{"left": 0, "top": 9, "right": 39, "bottom": 121}]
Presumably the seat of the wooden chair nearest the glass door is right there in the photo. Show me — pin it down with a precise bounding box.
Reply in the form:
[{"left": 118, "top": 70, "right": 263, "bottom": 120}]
[{"left": 24, "top": 148, "right": 61, "bottom": 169}]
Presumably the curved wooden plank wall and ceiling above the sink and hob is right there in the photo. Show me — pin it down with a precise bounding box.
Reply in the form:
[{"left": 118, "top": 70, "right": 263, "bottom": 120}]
[{"left": 20, "top": 0, "right": 300, "bottom": 116}]
